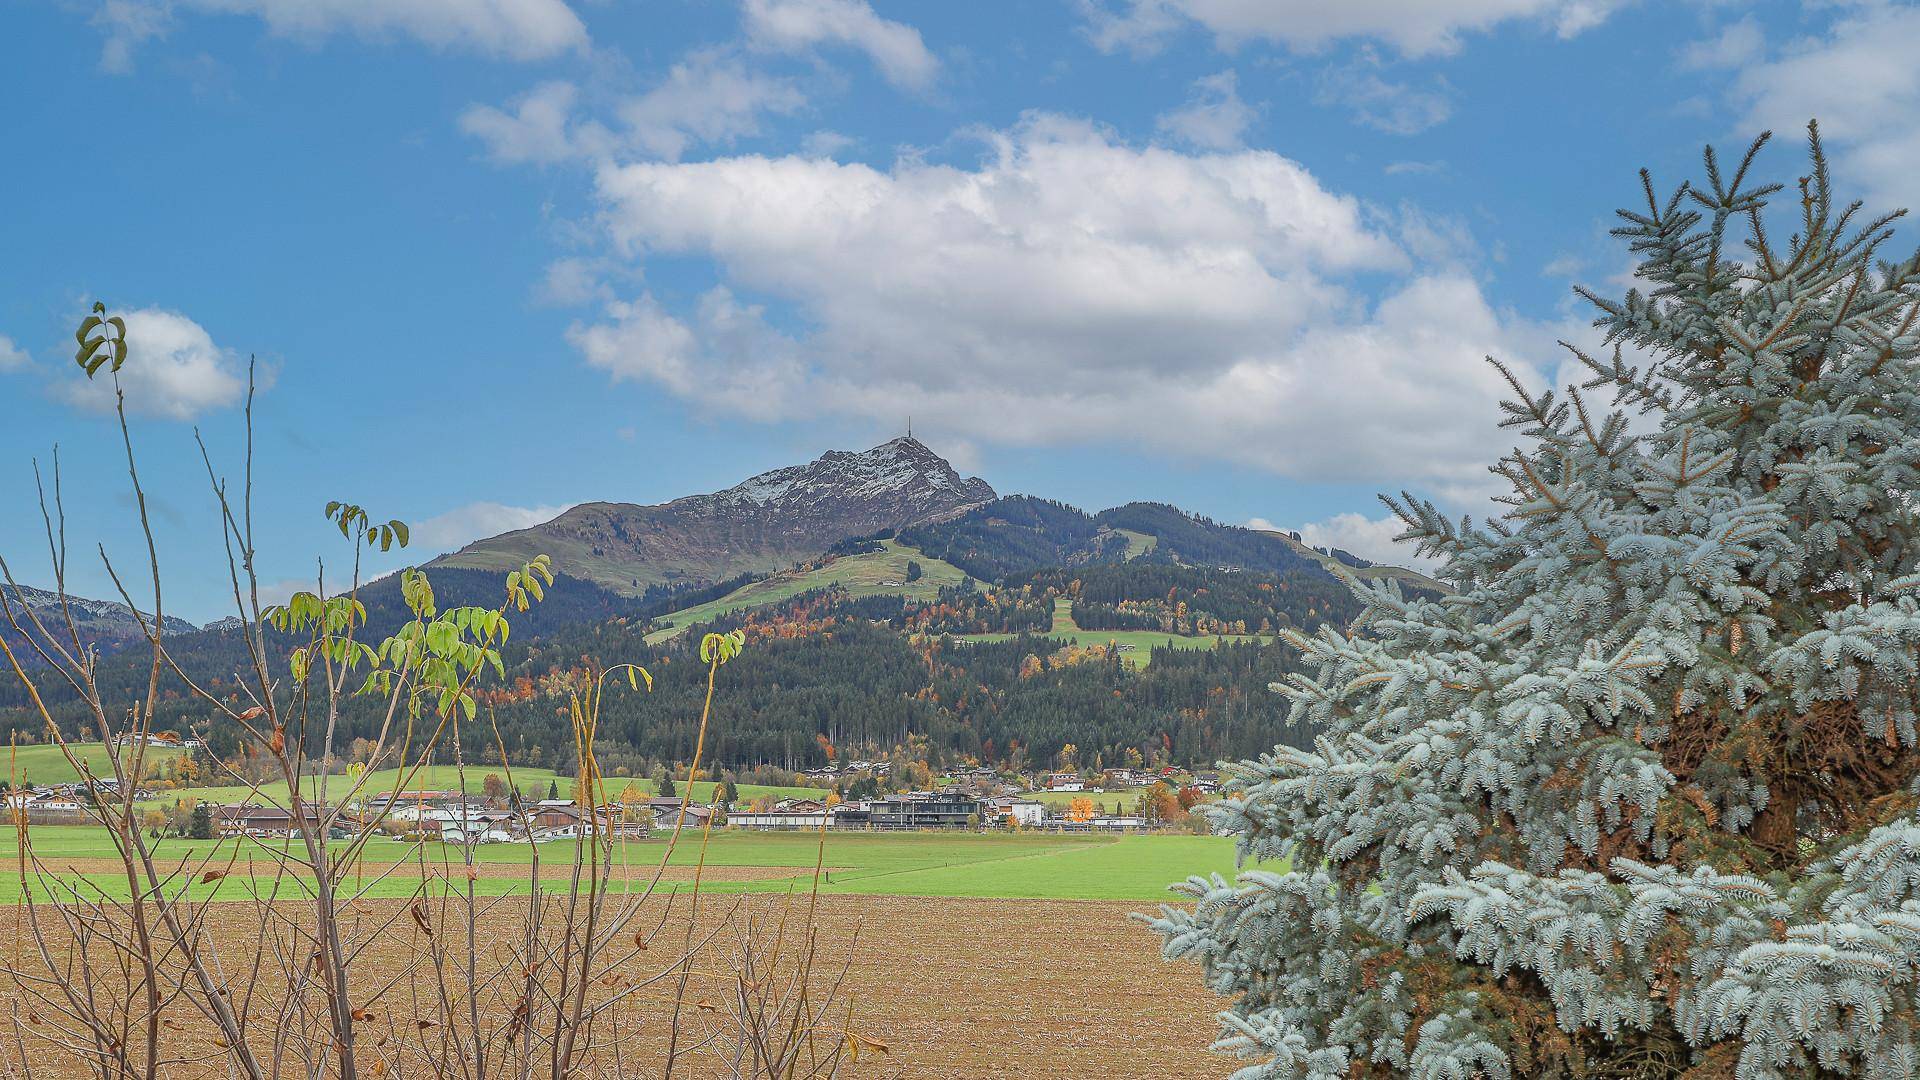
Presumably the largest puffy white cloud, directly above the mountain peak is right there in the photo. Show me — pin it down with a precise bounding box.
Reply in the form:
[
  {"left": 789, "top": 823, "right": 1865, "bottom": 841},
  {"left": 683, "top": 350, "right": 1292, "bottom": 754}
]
[{"left": 570, "top": 115, "right": 1551, "bottom": 492}]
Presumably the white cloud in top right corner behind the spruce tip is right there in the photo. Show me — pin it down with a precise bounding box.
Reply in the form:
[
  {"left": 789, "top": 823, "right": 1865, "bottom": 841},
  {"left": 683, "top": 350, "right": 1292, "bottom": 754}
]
[{"left": 1732, "top": 4, "right": 1920, "bottom": 209}]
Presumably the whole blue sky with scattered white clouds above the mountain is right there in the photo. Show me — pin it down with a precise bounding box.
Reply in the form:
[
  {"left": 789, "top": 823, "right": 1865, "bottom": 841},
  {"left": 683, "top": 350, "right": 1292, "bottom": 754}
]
[{"left": 0, "top": 0, "right": 1920, "bottom": 619}]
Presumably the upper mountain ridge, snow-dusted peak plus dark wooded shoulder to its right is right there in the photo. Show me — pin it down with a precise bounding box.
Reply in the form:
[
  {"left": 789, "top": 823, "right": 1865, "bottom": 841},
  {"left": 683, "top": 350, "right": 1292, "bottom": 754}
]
[{"left": 428, "top": 436, "right": 1434, "bottom": 598}]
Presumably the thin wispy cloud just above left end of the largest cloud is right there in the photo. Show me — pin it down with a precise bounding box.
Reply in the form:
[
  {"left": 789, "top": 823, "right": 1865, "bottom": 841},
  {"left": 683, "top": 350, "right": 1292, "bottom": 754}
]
[{"left": 459, "top": 50, "right": 806, "bottom": 163}]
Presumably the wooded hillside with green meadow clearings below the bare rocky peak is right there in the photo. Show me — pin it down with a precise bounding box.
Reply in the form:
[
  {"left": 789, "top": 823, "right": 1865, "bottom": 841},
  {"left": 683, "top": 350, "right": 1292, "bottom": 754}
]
[{"left": 0, "top": 459, "right": 1420, "bottom": 771}]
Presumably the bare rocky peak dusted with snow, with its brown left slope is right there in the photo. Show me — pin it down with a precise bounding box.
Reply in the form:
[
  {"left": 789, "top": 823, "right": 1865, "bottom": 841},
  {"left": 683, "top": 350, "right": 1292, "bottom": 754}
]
[{"left": 428, "top": 438, "right": 995, "bottom": 596}]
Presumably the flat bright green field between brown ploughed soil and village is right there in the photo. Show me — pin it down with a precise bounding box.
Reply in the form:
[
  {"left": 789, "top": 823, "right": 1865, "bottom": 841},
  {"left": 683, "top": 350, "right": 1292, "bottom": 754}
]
[{"left": 0, "top": 826, "right": 1235, "bottom": 903}]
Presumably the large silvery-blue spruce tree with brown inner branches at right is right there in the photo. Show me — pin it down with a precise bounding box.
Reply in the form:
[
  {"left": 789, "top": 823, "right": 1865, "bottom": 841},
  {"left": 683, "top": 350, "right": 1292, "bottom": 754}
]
[{"left": 1154, "top": 129, "right": 1920, "bottom": 1080}]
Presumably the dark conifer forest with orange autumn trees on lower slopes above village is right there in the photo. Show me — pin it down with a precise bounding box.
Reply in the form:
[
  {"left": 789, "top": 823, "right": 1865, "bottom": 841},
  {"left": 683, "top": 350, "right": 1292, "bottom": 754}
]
[{"left": 0, "top": 553, "right": 1352, "bottom": 773}]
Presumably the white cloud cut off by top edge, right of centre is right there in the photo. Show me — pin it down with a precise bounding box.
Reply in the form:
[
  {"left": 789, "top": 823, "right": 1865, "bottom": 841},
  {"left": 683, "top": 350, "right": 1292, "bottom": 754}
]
[{"left": 1081, "top": 0, "right": 1630, "bottom": 56}]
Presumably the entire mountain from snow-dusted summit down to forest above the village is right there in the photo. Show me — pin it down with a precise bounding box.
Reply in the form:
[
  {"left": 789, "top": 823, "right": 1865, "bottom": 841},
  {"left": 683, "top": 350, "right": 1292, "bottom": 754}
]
[{"left": 0, "top": 438, "right": 1440, "bottom": 773}]
